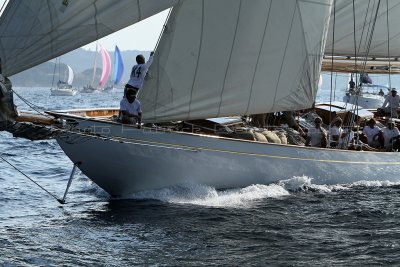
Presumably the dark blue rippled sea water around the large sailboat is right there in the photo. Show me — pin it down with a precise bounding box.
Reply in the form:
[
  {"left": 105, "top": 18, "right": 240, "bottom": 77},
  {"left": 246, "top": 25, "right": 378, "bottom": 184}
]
[{"left": 0, "top": 80, "right": 400, "bottom": 266}]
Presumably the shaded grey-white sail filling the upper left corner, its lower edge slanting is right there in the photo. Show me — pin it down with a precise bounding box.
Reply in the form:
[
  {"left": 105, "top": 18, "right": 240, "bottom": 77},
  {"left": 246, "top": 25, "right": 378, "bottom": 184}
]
[{"left": 0, "top": 0, "right": 176, "bottom": 76}]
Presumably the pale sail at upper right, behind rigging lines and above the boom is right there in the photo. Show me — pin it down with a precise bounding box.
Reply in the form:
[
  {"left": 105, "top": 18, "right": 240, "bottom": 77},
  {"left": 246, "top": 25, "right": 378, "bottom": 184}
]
[{"left": 325, "top": 0, "right": 400, "bottom": 58}]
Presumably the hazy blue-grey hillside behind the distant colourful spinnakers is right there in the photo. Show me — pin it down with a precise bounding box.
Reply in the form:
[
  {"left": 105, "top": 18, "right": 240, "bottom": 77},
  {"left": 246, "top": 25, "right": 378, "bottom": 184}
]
[{"left": 10, "top": 48, "right": 150, "bottom": 87}]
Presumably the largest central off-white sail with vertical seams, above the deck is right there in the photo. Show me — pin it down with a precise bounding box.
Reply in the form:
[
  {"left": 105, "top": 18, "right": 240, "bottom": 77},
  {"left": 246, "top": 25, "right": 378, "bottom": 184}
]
[{"left": 139, "top": 0, "right": 332, "bottom": 122}]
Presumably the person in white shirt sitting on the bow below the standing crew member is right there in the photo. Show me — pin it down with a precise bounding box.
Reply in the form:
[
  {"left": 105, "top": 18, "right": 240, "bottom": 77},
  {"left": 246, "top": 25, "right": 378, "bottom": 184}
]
[{"left": 120, "top": 88, "right": 142, "bottom": 129}]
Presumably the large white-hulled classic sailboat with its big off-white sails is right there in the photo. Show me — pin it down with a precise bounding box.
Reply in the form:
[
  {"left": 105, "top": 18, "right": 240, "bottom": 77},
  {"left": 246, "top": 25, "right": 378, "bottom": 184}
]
[{"left": 0, "top": 0, "right": 400, "bottom": 196}]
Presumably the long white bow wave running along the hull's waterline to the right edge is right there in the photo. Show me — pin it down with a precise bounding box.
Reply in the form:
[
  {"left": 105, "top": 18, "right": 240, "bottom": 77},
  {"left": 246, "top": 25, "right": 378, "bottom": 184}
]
[{"left": 116, "top": 176, "right": 400, "bottom": 208}]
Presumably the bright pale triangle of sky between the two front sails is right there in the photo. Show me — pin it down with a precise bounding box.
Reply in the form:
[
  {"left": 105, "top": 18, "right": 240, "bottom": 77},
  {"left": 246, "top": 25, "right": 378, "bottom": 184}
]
[{"left": 82, "top": 10, "right": 168, "bottom": 51}]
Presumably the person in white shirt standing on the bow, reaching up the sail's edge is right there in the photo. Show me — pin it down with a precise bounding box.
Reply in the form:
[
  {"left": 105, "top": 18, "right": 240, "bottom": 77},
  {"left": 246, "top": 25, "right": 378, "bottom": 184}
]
[{"left": 124, "top": 52, "right": 154, "bottom": 96}]
